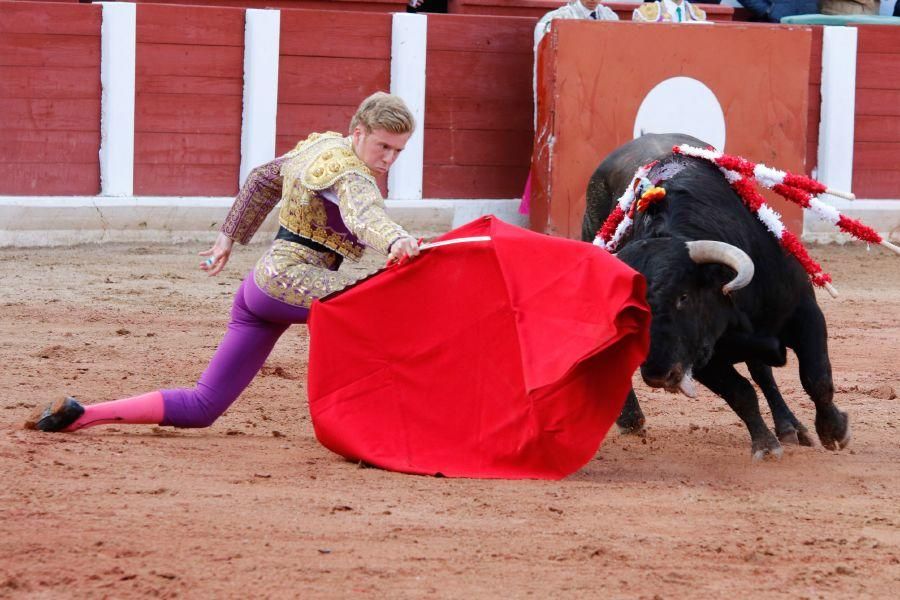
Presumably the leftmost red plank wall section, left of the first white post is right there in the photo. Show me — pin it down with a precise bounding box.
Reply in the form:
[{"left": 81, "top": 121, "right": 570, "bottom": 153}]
[{"left": 0, "top": 2, "right": 100, "bottom": 195}]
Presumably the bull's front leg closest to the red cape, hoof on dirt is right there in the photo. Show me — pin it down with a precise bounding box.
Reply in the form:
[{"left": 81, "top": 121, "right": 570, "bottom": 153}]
[{"left": 694, "top": 359, "right": 784, "bottom": 460}]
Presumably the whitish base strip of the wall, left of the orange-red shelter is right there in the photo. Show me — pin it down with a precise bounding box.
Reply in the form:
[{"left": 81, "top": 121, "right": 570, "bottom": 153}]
[{"left": 0, "top": 196, "right": 528, "bottom": 247}]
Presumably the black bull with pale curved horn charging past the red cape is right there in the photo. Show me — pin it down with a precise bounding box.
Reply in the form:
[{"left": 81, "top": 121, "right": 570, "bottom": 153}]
[{"left": 582, "top": 134, "right": 850, "bottom": 458}]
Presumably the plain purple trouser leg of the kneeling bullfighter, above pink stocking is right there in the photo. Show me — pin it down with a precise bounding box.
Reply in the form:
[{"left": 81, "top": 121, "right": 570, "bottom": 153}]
[{"left": 161, "top": 272, "right": 309, "bottom": 427}]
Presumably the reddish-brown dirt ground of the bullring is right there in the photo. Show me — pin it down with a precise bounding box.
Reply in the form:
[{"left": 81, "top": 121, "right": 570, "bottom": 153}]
[{"left": 0, "top": 237, "right": 900, "bottom": 599}]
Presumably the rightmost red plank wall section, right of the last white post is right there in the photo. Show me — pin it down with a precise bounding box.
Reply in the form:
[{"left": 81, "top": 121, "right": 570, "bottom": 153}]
[{"left": 853, "top": 25, "right": 900, "bottom": 198}]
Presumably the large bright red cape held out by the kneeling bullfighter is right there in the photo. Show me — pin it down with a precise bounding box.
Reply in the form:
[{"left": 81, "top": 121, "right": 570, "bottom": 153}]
[{"left": 309, "top": 217, "right": 650, "bottom": 479}]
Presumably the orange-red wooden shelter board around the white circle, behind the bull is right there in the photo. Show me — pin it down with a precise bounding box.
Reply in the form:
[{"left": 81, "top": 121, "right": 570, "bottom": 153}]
[{"left": 531, "top": 20, "right": 811, "bottom": 238}]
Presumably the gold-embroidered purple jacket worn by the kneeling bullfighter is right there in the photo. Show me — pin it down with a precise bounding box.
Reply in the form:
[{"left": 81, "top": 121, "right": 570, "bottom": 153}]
[{"left": 222, "top": 131, "right": 408, "bottom": 260}]
